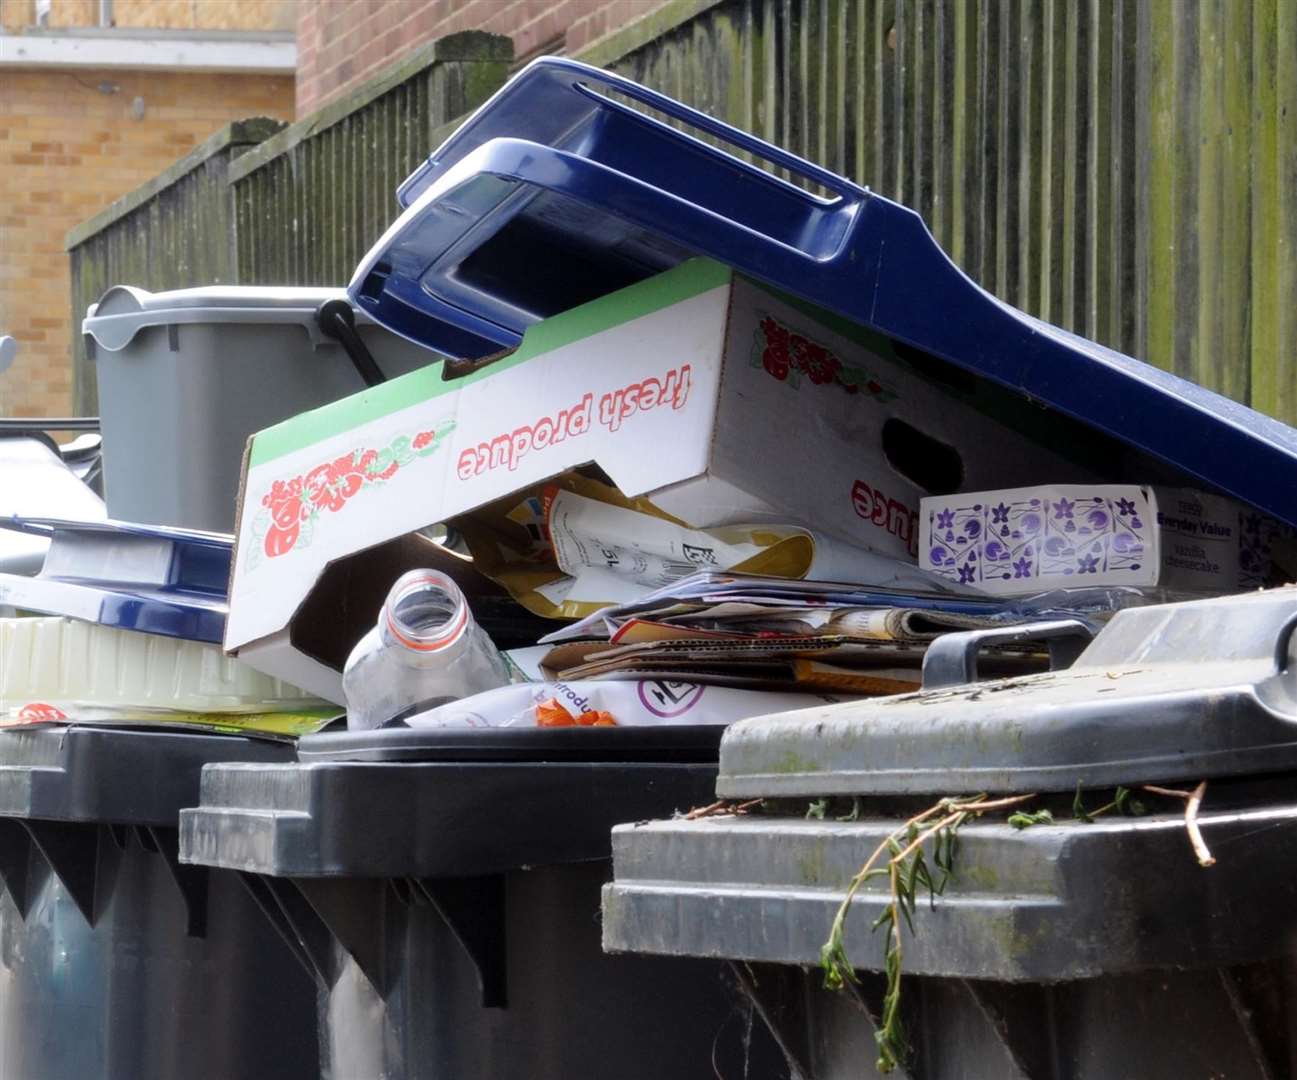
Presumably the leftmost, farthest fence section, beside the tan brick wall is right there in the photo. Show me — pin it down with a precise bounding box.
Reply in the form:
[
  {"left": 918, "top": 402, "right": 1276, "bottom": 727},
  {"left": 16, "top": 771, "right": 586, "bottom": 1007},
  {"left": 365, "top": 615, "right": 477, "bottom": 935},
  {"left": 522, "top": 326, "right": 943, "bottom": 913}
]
[{"left": 66, "top": 118, "right": 284, "bottom": 416}]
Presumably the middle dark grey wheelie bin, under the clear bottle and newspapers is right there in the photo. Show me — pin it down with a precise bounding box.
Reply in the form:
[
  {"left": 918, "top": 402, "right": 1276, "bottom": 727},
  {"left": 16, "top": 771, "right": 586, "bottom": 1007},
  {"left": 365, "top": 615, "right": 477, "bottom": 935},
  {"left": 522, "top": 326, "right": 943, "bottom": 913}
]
[{"left": 180, "top": 729, "right": 777, "bottom": 1080}]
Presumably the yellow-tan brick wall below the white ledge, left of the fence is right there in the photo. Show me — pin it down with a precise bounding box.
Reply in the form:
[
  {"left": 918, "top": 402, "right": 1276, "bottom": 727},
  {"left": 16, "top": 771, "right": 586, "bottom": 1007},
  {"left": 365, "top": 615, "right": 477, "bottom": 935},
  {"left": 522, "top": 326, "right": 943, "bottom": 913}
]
[{"left": 0, "top": 67, "right": 293, "bottom": 416}]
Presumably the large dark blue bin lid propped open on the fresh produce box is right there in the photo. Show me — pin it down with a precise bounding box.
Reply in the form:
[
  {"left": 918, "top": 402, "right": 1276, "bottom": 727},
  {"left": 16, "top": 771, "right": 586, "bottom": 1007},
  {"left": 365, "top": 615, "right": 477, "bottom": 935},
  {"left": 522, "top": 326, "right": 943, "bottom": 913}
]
[{"left": 348, "top": 58, "right": 1297, "bottom": 524}]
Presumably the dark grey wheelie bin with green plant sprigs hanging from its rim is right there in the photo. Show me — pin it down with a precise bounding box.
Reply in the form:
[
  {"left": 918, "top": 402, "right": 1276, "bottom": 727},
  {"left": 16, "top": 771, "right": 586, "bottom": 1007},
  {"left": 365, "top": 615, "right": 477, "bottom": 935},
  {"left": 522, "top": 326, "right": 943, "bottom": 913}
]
[{"left": 603, "top": 589, "right": 1297, "bottom": 1080}]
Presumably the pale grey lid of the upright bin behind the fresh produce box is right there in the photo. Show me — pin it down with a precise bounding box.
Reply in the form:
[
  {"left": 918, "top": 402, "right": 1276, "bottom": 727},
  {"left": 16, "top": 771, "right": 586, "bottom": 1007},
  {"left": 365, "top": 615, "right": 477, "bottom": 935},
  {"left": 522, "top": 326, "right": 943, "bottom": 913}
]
[{"left": 82, "top": 285, "right": 374, "bottom": 353}]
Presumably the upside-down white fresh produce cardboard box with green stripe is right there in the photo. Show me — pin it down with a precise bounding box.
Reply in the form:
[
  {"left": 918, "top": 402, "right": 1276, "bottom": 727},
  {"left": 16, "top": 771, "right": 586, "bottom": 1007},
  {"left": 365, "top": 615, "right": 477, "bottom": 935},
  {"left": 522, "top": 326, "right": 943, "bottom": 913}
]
[{"left": 226, "top": 259, "right": 1092, "bottom": 701}]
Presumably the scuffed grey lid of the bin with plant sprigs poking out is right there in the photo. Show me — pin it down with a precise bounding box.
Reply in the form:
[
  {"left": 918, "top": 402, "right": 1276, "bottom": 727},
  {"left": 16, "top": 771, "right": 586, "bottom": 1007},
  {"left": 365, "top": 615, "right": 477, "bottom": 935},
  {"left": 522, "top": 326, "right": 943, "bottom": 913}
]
[{"left": 716, "top": 587, "right": 1297, "bottom": 799}]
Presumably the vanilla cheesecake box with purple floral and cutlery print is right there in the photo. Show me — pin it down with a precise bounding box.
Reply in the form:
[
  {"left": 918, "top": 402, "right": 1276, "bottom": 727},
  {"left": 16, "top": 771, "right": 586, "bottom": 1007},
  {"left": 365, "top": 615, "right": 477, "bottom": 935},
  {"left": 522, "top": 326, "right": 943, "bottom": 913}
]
[{"left": 920, "top": 484, "right": 1250, "bottom": 596}]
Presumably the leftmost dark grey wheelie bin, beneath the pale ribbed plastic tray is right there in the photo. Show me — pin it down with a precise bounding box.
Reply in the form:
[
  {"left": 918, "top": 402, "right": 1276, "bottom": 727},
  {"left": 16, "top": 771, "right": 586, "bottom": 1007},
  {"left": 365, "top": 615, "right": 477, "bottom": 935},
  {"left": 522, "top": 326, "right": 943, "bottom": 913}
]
[{"left": 0, "top": 726, "right": 319, "bottom": 1080}]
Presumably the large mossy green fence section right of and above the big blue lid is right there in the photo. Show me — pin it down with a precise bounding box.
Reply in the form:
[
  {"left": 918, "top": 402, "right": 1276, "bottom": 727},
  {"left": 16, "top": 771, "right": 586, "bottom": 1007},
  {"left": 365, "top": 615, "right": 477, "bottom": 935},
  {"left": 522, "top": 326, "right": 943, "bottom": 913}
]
[{"left": 588, "top": 0, "right": 1297, "bottom": 421}]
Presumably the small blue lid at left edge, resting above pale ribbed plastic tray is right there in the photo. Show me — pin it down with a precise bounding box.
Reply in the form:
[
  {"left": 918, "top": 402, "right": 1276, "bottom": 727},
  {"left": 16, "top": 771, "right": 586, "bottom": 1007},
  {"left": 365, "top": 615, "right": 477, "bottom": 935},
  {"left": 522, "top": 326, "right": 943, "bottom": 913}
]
[{"left": 0, "top": 517, "right": 233, "bottom": 644}]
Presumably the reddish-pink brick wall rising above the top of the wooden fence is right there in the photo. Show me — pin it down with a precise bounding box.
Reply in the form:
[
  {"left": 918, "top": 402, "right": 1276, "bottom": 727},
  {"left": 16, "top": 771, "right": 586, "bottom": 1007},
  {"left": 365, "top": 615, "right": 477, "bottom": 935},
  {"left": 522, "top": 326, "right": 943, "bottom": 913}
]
[{"left": 297, "top": 0, "right": 664, "bottom": 115}]
